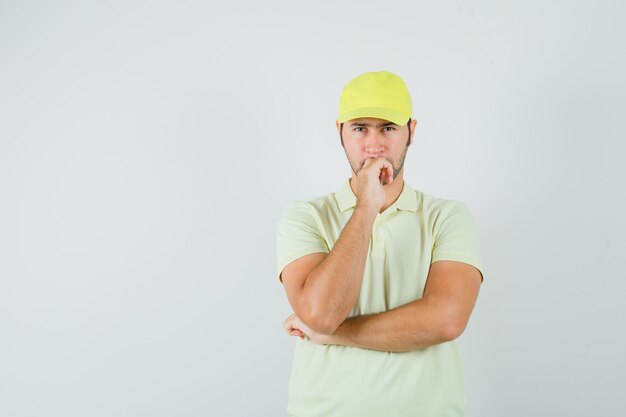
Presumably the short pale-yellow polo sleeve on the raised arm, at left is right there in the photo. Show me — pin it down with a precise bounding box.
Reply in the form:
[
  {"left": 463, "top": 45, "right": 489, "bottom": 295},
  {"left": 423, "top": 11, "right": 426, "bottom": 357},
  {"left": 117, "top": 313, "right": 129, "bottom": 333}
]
[{"left": 276, "top": 201, "right": 330, "bottom": 279}]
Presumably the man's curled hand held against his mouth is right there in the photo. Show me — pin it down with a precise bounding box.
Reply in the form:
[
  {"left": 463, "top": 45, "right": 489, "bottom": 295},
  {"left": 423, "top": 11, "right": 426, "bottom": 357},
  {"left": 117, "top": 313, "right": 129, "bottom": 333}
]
[{"left": 355, "top": 157, "right": 393, "bottom": 213}]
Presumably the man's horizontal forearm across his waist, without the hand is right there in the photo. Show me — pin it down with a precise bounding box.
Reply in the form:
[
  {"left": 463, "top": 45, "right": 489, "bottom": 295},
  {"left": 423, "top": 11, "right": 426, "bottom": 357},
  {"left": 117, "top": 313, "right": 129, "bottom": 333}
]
[{"left": 329, "top": 299, "right": 462, "bottom": 352}]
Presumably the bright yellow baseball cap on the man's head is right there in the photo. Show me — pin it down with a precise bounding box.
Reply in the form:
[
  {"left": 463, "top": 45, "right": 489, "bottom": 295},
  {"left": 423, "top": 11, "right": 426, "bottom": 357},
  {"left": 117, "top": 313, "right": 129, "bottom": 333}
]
[{"left": 337, "top": 71, "right": 413, "bottom": 125}]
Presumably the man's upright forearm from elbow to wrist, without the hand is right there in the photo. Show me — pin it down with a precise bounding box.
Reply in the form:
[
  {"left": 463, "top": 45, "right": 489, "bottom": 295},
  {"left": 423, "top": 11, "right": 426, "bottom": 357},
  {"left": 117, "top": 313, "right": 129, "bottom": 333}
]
[{"left": 302, "top": 206, "right": 376, "bottom": 334}]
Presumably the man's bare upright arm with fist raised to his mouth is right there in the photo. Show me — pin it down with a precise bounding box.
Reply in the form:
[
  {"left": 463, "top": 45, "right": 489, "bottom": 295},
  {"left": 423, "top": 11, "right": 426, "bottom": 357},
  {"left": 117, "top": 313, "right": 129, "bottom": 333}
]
[{"left": 281, "top": 158, "right": 393, "bottom": 334}]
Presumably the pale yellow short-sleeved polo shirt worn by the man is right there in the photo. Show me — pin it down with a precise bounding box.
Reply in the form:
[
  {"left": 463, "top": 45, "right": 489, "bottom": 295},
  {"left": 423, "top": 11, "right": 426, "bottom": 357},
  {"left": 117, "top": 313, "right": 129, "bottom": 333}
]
[{"left": 276, "top": 180, "right": 482, "bottom": 417}]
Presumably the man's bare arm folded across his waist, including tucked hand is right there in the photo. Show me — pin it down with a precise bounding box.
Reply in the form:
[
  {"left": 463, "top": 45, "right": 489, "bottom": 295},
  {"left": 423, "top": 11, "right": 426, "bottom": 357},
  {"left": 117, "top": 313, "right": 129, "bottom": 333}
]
[{"left": 285, "top": 261, "right": 481, "bottom": 352}]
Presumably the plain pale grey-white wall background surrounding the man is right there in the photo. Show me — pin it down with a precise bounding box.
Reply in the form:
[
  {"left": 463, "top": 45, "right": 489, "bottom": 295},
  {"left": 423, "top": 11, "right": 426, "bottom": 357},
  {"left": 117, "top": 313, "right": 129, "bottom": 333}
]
[{"left": 0, "top": 1, "right": 626, "bottom": 417}]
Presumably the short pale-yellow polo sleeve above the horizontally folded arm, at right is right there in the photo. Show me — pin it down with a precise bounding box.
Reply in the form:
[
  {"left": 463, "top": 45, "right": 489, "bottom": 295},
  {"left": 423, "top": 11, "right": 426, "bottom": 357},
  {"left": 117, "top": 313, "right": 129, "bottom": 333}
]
[{"left": 431, "top": 200, "right": 483, "bottom": 280}]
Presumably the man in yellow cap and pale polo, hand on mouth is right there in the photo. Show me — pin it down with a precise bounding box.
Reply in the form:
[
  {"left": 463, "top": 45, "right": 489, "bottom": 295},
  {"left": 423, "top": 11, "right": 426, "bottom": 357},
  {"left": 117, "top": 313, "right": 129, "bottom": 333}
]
[{"left": 277, "top": 71, "right": 483, "bottom": 417}]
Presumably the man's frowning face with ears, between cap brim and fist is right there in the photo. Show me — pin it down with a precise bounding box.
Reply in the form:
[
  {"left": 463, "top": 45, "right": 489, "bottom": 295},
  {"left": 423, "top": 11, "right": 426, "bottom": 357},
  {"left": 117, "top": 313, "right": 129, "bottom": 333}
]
[{"left": 337, "top": 117, "right": 417, "bottom": 179}]
